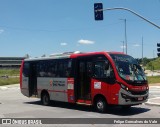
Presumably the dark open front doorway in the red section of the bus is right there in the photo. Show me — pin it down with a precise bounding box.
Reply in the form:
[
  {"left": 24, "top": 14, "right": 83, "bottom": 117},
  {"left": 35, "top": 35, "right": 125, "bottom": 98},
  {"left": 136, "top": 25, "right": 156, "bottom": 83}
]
[{"left": 76, "top": 59, "right": 92, "bottom": 103}]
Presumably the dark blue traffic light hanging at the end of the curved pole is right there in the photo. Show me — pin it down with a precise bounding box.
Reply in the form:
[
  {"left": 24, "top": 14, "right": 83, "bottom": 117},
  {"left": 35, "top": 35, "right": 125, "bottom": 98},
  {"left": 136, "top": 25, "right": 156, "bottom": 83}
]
[{"left": 94, "top": 3, "right": 103, "bottom": 20}]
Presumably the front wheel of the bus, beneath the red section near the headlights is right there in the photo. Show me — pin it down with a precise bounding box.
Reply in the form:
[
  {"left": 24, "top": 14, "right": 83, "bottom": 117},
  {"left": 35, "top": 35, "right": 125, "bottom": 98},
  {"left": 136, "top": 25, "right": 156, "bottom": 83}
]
[{"left": 95, "top": 97, "right": 107, "bottom": 113}]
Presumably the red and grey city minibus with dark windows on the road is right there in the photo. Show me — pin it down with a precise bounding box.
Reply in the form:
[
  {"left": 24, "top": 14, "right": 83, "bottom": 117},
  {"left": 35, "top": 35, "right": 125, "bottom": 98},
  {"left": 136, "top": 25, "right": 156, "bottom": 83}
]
[{"left": 20, "top": 52, "right": 149, "bottom": 112}]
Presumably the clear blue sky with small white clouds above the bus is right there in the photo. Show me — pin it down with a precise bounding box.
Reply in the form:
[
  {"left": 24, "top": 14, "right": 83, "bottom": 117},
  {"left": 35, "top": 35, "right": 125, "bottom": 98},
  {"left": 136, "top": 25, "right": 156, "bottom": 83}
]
[{"left": 0, "top": 0, "right": 160, "bottom": 58}]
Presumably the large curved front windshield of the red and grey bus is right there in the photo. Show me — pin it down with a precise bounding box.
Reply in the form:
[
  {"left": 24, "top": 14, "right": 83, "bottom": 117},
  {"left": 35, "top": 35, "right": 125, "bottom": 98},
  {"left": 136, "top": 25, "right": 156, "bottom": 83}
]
[{"left": 110, "top": 54, "right": 146, "bottom": 83}]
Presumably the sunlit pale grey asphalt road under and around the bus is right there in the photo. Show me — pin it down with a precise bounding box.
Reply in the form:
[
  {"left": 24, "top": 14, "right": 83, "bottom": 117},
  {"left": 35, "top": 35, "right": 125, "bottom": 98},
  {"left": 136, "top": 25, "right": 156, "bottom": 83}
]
[{"left": 0, "top": 86, "right": 160, "bottom": 127}]
